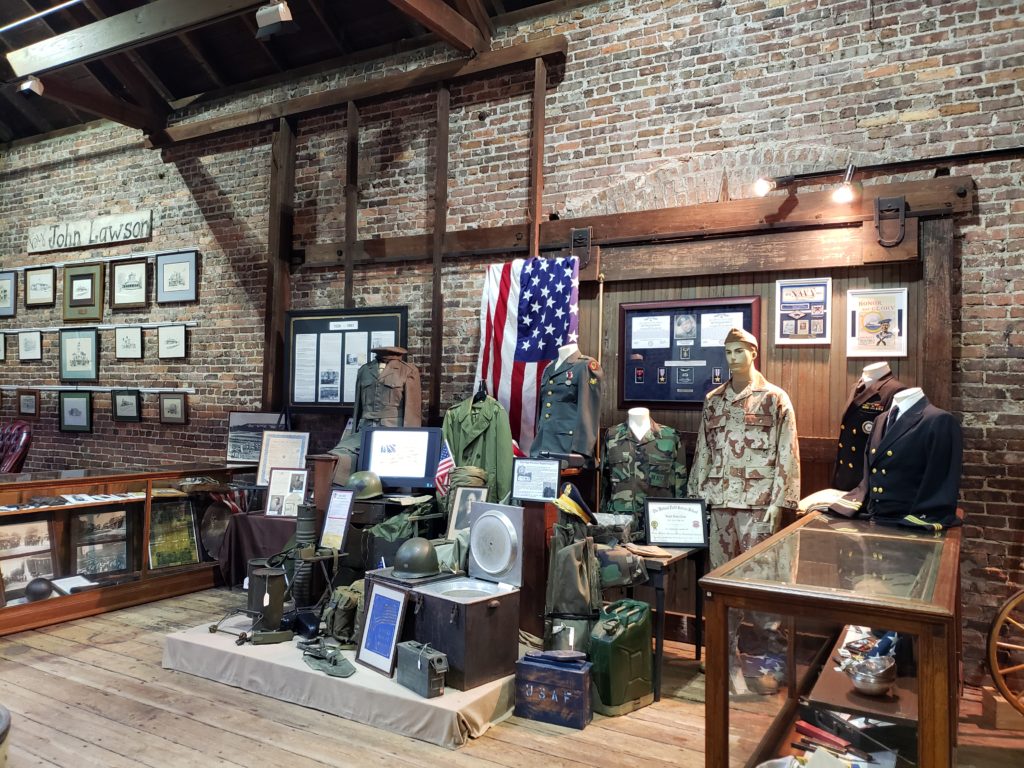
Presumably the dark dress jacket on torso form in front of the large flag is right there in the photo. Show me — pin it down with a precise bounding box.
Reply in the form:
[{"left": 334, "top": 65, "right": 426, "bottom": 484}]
[{"left": 529, "top": 350, "right": 604, "bottom": 459}]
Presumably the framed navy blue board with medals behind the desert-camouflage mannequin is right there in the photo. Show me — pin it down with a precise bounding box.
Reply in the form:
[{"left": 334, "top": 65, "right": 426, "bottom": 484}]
[{"left": 618, "top": 296, "right": 761, "bottom": 409}]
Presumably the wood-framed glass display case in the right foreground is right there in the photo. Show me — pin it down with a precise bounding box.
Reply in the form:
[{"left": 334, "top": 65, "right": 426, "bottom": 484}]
[{"left": 700, "top": 513, "right": 961, "bottom": 767}]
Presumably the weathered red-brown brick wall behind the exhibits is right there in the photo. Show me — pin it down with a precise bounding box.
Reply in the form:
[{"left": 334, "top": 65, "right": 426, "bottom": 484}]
[{"left": 0, "top": 0, "right": 1024, "bottom": 682}]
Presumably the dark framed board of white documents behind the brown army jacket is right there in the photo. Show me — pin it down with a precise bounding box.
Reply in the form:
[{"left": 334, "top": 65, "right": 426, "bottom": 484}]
[{"left": 285, "top": 306, "right": 409, "bottom": 412}]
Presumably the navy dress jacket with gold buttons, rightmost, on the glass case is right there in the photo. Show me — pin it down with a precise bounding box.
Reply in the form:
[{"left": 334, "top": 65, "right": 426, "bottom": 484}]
[{"left": 829, "top": 396, "right": 964, "bottom": 530}]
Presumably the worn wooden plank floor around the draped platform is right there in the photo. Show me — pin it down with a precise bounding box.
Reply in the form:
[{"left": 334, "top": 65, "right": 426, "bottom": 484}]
[{"left": 0, "top": 590, "right": 1024, "bottom": 768}]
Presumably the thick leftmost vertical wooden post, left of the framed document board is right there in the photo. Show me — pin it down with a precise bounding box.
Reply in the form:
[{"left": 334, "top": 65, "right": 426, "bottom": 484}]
[{"left": 262, "top": 119, "right": 295, "bottom": 411}]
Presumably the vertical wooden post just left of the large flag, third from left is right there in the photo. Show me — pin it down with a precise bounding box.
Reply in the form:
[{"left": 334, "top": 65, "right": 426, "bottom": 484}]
[{"left": 427, "top": 84, "right": 452, "bottom": 427}]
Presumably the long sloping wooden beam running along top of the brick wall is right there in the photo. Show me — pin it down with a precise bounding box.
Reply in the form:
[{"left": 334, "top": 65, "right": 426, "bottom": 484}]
[{"left": 154, "top": 35, "right": 568, "bottom": 146}]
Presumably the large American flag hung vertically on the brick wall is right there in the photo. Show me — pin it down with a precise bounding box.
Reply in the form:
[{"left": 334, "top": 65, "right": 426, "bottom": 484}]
[{"left": 476, "top": 256, "right": 580, "bottom": 453}]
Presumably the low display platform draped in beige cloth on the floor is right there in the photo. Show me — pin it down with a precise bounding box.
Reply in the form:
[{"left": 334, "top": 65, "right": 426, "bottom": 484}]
[{"left": 163, "top": 616, "right": 515, "bottom": 749}]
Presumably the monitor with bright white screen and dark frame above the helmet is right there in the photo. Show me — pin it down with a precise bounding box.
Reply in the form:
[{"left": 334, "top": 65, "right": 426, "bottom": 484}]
[{"left": 359, "top": 427, "right": 444, "bottom": 488}]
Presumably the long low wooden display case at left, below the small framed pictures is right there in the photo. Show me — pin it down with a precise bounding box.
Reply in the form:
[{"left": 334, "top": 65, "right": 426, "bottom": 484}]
[{"left": 0, "top": 464, "right": 252, "bottom": 635}]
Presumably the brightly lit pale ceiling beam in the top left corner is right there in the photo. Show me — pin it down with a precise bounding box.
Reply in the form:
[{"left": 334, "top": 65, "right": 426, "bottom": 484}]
[{"left": 7, "top": 0, "right": 262, "bottom": 77}]
